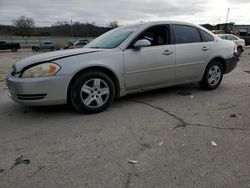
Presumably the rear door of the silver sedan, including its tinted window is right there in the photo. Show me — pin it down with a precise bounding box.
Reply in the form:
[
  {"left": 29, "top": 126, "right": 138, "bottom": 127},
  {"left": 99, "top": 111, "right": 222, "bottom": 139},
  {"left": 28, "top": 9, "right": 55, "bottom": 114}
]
[{"left": 173, "top": 24, "right": 211, "bottom": 82}]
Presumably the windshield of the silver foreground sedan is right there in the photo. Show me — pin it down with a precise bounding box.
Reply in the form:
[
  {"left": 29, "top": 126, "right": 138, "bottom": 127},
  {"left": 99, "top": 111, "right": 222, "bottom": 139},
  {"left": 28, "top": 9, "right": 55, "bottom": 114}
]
[{"left": 85, "top": 25, "right": 140, "bottom": 48}]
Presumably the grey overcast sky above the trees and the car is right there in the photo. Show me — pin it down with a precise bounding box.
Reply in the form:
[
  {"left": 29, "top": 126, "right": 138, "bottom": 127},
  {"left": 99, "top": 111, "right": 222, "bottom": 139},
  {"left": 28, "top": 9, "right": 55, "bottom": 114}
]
[{"left": 0, "top": 0, "right": 250, "bottom": 26}]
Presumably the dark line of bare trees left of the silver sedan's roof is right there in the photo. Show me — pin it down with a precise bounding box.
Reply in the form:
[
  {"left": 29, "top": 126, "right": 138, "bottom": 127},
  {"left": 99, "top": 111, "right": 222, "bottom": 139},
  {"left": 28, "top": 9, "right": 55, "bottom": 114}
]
[{"left": 0, "top": 16, "right": 119, "bottom": 37}]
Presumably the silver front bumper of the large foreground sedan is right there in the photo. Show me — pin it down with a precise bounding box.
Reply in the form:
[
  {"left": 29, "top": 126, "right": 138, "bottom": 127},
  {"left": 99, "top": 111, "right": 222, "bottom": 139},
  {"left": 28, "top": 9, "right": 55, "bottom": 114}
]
[{"left": 6, "top": 75, "right": 70, "bottom": 106}]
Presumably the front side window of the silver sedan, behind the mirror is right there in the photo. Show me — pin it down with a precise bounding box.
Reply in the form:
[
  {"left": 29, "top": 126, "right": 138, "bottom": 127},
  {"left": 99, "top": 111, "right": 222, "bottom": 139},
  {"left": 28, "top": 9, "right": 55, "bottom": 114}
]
[{"left": 129, "top": 25, "right": 170, "bottom": 48}]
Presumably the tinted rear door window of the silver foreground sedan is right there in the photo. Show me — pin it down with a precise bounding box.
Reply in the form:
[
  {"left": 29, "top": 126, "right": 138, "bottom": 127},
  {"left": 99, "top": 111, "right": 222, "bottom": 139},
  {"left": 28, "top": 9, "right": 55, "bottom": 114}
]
[{"left": 173, "top": 25, "right": 201, "bottom": 44}]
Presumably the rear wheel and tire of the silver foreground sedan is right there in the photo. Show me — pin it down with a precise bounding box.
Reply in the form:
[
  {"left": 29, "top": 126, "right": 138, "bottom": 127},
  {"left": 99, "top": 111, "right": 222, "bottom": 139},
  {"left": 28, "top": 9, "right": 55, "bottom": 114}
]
[{"left": 199, "top": 60, "right": 224, "bottom": 90}]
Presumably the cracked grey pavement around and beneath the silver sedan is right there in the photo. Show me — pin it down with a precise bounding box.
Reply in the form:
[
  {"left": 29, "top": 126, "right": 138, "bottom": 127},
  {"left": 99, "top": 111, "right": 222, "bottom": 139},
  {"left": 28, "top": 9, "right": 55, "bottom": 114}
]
[{"left": 0, "top": 49, "right": 250, "bottom": 188}]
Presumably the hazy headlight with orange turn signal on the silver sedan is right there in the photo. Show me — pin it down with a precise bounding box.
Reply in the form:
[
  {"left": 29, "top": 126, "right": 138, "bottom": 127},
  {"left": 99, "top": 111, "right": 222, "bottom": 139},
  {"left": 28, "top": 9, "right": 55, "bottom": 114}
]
[{"left": 21, "top": 63, "right": 60, "bottom": 78}]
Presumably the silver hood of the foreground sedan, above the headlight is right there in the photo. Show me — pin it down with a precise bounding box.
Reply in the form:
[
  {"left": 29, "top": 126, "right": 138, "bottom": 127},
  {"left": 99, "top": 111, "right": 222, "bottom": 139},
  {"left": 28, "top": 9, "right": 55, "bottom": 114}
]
[{"left": 13, "top": 48, "right": 104, "bottom": 72}]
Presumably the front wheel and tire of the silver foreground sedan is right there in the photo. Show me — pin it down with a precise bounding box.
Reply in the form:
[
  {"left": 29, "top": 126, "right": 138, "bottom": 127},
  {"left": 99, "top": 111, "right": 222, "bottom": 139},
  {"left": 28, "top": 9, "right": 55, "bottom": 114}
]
[{"left": 69, "top": 71, "right": 115, "bottom": 114}]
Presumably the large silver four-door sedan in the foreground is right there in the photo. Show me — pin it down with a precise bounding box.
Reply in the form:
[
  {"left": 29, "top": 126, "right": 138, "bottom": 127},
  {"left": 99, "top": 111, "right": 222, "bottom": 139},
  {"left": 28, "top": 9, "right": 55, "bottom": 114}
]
[{"left": 7, "top": 21, "right": 238, "bottom": 113}]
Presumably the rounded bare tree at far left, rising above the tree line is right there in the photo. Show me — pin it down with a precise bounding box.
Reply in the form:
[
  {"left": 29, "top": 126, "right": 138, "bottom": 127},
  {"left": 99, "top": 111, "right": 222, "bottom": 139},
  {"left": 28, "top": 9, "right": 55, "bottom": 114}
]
[{"left": 12, "top": 16, "right": 35, "bottom": 37}]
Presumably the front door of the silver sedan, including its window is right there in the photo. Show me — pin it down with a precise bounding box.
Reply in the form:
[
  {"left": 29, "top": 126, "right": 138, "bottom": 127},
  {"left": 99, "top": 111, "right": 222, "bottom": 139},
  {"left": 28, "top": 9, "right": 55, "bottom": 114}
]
[{"left": 124, "top": 25, "right": 175, "bottom": 89}]
